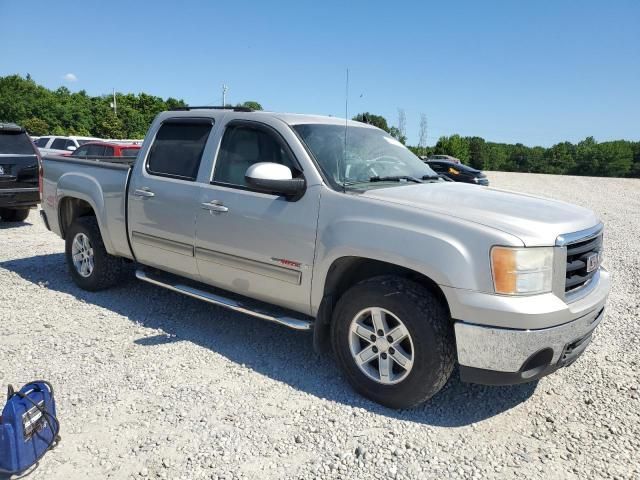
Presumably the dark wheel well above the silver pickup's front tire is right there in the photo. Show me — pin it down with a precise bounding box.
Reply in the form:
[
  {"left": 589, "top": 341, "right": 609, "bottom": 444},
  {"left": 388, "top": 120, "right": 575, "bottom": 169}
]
[{"left": 323, "top": 257, "right": 449, "bottom": 320}]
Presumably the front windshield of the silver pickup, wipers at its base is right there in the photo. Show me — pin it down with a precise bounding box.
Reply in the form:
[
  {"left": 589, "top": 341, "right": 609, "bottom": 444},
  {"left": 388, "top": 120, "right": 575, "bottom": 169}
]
[{"left": 293, "top": 124, "right": 437, "bottom": 188}]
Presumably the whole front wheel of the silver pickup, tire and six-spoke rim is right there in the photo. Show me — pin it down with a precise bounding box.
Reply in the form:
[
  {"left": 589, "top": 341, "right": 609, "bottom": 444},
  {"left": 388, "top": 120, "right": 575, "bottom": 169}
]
[{"left": 331, "top": 276, "right": 455, "bottom": 408}]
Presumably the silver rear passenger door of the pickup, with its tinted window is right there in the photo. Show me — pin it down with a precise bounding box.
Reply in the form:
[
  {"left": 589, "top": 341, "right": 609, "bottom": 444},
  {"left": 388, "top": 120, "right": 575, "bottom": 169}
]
[{"left": 128, "top": 117, "right": 213, "bottom": 280}]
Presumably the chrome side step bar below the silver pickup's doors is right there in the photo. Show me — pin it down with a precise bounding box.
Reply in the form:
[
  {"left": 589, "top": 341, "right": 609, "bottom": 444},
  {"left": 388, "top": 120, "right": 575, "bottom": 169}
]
[{"left": 136, "top": 270, "right": 313, "bottom": 330}]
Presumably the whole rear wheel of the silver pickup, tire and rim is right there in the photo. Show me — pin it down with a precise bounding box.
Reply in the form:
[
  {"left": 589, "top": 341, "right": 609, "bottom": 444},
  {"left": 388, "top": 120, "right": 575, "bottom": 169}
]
[{"left": 65, "top": 217, "right": 123, "bottom": 291}]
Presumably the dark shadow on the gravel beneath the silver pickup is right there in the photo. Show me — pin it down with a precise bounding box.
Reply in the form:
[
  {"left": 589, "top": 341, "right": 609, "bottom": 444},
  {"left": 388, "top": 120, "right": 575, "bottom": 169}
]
[{"left": 0, "top": 253, "right": 536, "bottom": 427}]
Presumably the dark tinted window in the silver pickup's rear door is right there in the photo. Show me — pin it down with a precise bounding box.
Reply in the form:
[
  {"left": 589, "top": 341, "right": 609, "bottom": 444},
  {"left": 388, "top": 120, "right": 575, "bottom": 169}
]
[{"left": 147, "top": 119, "right": 213, "bottom": 181}]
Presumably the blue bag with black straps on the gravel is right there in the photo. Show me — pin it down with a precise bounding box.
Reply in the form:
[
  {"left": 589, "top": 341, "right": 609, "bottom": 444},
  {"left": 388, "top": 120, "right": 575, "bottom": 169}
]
[{"left": 0, "top": 380, "right": 60, "bottom": 474}]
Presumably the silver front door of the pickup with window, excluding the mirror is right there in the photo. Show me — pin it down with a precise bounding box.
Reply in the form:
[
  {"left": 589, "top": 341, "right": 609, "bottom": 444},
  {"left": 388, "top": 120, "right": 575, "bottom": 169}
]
[{"left": 191, "top": 120, "right": 320, "bottom": 313}]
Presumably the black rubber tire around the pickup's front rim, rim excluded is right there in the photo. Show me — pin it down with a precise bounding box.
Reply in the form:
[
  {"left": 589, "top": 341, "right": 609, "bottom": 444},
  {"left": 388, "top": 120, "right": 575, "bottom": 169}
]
[{"left": 331, "top": 276, "right": 455, "bottom": 408}]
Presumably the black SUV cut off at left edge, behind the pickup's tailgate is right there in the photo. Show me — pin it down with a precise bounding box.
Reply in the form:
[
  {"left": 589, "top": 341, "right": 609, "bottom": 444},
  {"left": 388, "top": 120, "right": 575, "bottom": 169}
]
[{"left": 0, "top": 123, "right": 40, "bottom": 222}]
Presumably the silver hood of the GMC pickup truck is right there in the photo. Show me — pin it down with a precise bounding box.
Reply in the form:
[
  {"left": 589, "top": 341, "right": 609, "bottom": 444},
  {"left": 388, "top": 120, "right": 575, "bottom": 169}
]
[{"left": 364, "top": 182, "right": 599, "bottom": 246}]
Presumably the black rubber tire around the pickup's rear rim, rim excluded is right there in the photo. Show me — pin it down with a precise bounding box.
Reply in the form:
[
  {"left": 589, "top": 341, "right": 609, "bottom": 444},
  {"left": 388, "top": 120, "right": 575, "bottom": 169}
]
[{"left": 65, "top": 217, "right": 124, "bottom": 292}]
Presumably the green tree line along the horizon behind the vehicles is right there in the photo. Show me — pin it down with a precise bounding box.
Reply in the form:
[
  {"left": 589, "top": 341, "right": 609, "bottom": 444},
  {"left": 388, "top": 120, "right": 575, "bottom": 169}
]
[{"left": 0, "top": 75, "right": 640, "bottom": 177}]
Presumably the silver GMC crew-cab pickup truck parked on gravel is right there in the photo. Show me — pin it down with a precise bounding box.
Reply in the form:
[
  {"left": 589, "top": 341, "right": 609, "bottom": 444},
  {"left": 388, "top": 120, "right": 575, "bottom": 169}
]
[{"left": 42, "top": 108, "right": 610, "bottom": 408}]
